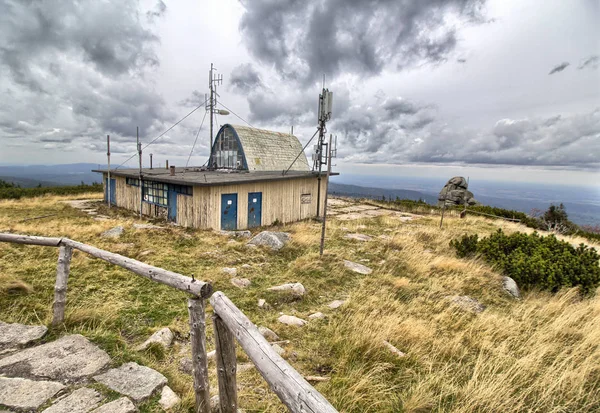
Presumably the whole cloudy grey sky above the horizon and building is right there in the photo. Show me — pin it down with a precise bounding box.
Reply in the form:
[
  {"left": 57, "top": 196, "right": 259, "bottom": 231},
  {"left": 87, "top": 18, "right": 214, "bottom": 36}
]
[{"left": 0, "top": 0, "right": 600, "bottom": 184}]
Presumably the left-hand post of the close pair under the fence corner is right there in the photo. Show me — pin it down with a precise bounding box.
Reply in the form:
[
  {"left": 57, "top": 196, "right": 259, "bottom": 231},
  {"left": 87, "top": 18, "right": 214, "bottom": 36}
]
[{"left": 188, "top": 298, "right": 210, "bottom": 413}]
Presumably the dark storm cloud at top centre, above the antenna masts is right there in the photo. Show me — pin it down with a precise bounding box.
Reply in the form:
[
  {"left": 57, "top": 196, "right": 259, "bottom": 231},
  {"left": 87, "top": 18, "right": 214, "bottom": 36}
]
[{"left": 240, "top": 0, "right": 485, "bottom": 82}]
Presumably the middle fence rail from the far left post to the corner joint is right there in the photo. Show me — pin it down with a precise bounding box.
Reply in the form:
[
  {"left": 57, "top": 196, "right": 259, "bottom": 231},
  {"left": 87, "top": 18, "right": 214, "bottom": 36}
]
[{"left": 62, "top": 238, "right": 212, "bottom": 298}]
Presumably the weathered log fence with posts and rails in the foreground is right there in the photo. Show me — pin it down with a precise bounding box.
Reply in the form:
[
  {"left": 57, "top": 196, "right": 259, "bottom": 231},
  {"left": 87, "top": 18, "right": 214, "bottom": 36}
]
[{"left": 0, "top": 233, "right": 337, "bottom": 413}]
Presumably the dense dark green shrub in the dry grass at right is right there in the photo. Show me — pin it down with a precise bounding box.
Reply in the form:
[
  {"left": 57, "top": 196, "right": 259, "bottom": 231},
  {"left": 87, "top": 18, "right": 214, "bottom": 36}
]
[{"left": 450, "top": 230, "right": 600, "bottom": 293}]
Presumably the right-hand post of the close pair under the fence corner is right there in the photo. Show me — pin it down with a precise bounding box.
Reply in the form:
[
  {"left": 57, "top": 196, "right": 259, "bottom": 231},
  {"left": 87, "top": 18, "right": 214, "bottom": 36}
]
[{"left": 213, "top": 314, "right": 237, "bottom": 413}]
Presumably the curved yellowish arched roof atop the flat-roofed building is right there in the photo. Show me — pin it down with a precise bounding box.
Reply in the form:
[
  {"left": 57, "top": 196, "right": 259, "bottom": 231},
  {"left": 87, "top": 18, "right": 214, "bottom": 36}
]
[{"left": 213, "top": 124, "right": 310, "bottom": 171}]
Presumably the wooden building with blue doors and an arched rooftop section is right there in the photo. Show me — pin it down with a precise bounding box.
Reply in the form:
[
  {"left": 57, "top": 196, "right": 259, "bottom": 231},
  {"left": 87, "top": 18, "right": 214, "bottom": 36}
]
[{"left": 95, "top": 124, "right": 336, "bottom": 230}]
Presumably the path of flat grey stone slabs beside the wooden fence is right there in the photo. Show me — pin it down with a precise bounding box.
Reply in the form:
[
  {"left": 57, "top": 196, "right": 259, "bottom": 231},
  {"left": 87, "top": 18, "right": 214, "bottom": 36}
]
[{"left": 0, "top": 322, "right": 174, "bottom": 413}]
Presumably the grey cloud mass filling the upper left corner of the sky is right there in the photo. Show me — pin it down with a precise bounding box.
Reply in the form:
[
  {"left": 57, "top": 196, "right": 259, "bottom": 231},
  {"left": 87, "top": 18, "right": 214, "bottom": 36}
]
[{"left": 0, "top": 0, "right": 172, "bottom": 150}]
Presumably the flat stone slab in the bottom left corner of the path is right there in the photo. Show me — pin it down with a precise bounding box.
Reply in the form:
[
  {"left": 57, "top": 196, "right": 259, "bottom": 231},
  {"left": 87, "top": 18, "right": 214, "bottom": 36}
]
[{"left": 0, "top": 377, "right": 65, "bottom": 409}]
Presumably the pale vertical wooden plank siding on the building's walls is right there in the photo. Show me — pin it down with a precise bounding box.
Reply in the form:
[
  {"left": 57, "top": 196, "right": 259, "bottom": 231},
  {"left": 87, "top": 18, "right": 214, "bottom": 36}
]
[{"left": 103, "top": 174, "right": 325, "bottom": 230}]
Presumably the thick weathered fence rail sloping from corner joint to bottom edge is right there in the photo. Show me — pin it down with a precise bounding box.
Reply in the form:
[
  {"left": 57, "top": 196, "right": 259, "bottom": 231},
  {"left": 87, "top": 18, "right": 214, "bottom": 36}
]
[{"left": 210, "top": 291, "right": 337, "bottom": 413}]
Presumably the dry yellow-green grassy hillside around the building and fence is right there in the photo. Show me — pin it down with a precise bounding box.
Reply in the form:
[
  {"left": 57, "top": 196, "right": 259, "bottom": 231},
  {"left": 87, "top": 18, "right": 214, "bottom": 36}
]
[{"left": 0, "top": 194, "right": 600, "bottom": 413}]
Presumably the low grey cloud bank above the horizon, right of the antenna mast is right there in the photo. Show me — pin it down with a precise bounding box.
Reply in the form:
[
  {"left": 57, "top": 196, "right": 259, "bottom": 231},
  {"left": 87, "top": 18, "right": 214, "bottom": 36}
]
[{"left": 336, "top": 107, "right": 600, "bottom": 169}]
